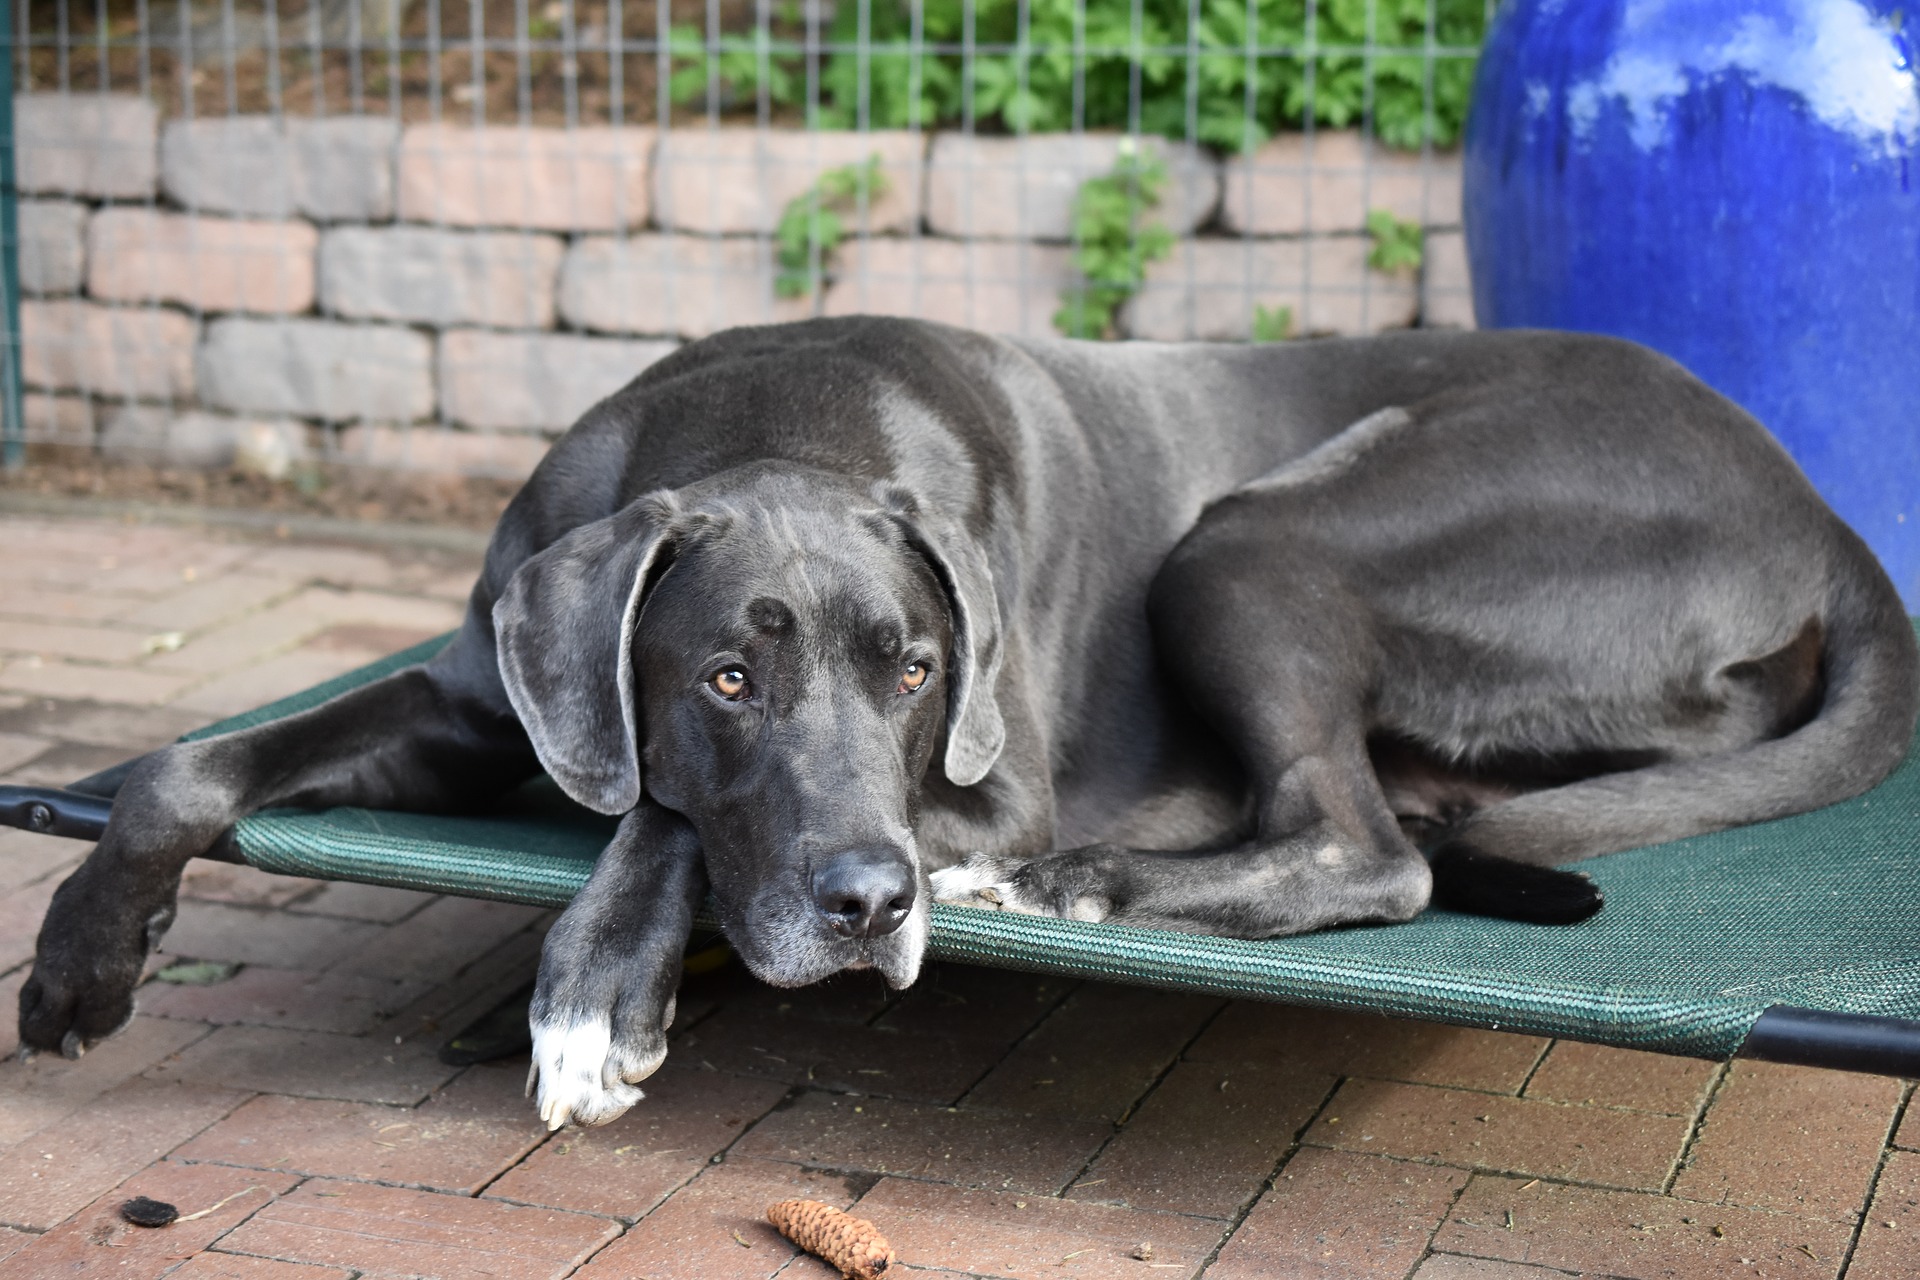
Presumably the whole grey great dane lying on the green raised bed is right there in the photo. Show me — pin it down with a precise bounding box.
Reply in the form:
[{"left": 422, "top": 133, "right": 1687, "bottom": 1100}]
[{"left": 21, "top": 319, "right": 1920, "bottom": 1126}]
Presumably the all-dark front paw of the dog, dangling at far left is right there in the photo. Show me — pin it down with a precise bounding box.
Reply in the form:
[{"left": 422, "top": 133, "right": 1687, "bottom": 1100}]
[{"left": 19, "top": 867, "right": 173, "bottom": 1057}]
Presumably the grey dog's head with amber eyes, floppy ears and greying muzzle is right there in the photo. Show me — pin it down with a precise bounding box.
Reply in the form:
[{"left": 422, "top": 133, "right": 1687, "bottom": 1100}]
[{"left": 493, "top": 464, "right": 1004, "bottom": 986}]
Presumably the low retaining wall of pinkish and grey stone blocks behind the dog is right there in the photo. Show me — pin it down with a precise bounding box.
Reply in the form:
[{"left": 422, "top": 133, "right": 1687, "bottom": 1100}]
[{"left": 15, "top": 94, "right": 1473, "bottom": 474}]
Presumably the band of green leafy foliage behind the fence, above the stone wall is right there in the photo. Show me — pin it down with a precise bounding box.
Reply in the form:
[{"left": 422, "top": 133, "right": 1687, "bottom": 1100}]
[{"left": 670, "top": 0, "right": 1486, "bottom": 150}]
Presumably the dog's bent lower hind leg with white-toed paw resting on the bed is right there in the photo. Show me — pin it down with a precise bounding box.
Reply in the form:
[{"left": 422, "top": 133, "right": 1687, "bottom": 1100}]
[{"left": 935, "top": 555, "right": 1430, "bottom": 936}]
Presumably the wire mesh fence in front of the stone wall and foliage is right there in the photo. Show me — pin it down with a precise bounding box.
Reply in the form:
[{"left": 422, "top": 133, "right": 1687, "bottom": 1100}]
[{"left": 10, "top": 0, "right": 1486, "bottom": 476}]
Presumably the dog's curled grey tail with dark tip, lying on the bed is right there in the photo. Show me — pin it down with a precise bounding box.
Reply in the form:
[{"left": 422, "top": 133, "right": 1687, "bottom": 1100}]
[{"left": 1434, "top": 545, "right": 1920, "bottom": 919}]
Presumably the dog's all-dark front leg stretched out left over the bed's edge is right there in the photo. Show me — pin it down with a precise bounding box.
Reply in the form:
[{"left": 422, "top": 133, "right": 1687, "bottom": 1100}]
[{"left": 19, "top": 624, "right": 538, "bottom": 1057}]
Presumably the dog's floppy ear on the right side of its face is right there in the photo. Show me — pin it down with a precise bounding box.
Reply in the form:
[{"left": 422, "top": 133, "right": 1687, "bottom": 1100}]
[{"left": 874, "top": 482, "right": 1006, "bottom": 787}]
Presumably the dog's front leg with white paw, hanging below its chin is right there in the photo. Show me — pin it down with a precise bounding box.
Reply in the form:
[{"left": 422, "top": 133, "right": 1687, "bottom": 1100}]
[{"left": 526, "top": 798, "right": 707, "bottom": 1128}]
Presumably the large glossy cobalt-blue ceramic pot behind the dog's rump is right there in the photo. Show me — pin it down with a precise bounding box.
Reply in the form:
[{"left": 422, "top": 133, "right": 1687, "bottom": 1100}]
[{"left": 1465, "top": 0, "right": 1920, "bottom": 612}]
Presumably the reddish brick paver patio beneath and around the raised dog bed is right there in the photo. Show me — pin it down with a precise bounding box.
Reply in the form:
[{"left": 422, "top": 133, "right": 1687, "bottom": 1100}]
[{"left": 0, "top": 516, "right": 1920, "bottom": 1280}]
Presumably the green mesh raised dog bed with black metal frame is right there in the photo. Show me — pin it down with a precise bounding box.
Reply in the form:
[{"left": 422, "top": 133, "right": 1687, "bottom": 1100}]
[{"left": 0, "top": 641, "right": 1920, "bottom": 1075}]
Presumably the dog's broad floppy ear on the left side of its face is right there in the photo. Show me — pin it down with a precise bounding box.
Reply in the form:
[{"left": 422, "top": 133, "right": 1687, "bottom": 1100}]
[{"left": 493, "top": 491, "right": 678, "bottom": 814}]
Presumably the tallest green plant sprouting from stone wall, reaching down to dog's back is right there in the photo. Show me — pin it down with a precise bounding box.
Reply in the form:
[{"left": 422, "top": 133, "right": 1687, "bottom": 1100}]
[{"left": 1054, "top": 138, "right": 1173, "bottom": 338}]
